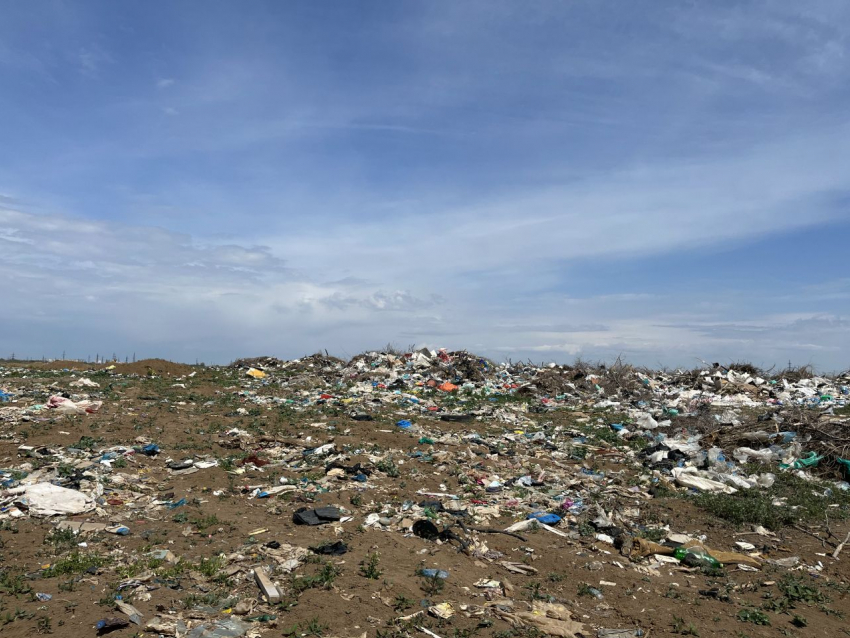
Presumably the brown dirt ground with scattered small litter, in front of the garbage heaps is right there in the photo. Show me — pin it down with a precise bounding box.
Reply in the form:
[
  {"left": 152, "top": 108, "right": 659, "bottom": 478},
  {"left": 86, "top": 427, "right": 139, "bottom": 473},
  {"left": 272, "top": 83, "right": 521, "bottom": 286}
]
[{"left": 0, "top": 360, "right": 850, "bottom": 638}]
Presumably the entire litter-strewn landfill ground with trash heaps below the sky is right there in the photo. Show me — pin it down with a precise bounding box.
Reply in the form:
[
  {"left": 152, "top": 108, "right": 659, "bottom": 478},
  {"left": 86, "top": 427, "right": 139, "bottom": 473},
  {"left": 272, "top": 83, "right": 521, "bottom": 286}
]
[{"left": 0, "top": 349, "right": 850, "bottom": 638}]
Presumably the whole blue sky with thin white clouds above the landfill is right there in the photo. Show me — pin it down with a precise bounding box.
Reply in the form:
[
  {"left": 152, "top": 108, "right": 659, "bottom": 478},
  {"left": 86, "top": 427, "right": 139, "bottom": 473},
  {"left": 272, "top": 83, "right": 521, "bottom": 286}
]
[{"left": 0, "top": 0, "right": 850, "bottom": 371}]
